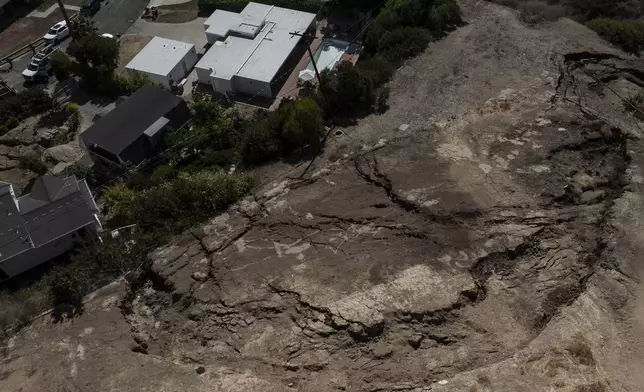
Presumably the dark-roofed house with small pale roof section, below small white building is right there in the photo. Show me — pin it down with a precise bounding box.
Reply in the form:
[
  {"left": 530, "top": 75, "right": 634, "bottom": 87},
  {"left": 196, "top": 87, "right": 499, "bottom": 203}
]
[{"left": 81, "top": 85, "right": 190, "bottom": 173}]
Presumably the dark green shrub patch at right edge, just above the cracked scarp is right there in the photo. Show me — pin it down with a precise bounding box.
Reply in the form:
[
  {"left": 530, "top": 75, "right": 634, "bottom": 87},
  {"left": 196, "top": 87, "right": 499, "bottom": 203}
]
[{"left": 586, "top": 19, "right": 644, "bottom": 54}]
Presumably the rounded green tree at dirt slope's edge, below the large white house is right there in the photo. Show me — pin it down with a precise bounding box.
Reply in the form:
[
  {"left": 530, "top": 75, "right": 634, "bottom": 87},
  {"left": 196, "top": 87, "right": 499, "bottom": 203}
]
[{"left": 282, "top": 98, "right": 324, "bottom": 151}]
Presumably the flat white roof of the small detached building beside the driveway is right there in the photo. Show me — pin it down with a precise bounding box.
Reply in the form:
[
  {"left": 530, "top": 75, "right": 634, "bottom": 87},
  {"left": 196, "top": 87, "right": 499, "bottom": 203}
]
[{"left": 125, "top": 37, "right": 194, "bottom": 75}]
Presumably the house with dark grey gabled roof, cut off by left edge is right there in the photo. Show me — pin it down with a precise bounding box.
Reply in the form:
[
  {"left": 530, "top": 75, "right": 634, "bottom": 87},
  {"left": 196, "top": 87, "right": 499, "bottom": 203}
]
[{"left": 0, "top": 175, "right": 102, "bottom": 280}]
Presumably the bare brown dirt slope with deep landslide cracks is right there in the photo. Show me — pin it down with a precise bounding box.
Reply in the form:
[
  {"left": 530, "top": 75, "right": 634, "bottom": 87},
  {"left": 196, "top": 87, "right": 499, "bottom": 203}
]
[{"left": 0, "top": 0, "right": 644, "bottom": 392}]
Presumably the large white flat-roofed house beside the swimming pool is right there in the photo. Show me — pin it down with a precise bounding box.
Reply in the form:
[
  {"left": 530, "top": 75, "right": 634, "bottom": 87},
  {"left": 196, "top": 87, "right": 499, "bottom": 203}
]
[{"left": 195, "top": 2, "right": 315, "bottom": 98}]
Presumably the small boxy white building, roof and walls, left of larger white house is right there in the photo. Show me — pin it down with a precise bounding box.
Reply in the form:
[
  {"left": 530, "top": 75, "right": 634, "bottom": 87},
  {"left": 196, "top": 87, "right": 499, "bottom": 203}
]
[{"left": 125, "top": 37, "right": 198, "bottom": 86}]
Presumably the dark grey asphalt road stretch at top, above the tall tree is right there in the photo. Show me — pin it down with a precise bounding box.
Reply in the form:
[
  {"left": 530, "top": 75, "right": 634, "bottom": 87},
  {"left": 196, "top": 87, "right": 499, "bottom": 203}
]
[{"left": 93, "top": 0, "right": 149, "bottom": 35}]
